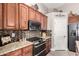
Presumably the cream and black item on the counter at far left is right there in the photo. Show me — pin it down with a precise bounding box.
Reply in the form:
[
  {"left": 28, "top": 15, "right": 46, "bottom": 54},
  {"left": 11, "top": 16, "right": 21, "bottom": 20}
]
[{"left": 0, "top": 34, "right": 11, "bottom": 46}]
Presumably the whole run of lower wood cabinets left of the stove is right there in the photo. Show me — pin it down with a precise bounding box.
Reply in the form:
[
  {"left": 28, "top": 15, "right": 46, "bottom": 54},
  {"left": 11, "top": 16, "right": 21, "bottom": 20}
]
[{"left": 2, "top": 45, "right": 33, "bottom": 56}]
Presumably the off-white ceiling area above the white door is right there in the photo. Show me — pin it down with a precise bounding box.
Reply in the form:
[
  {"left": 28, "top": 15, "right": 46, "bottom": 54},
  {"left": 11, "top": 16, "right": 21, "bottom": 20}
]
[{"left": 38, "top": 3, "right": 64, "bottom": 13}]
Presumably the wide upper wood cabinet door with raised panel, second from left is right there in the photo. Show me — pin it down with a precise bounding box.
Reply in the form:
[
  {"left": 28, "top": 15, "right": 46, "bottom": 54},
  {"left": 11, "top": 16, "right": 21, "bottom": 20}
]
[{"left": 4, "top": 3, "right": 18, "bottom": 29}]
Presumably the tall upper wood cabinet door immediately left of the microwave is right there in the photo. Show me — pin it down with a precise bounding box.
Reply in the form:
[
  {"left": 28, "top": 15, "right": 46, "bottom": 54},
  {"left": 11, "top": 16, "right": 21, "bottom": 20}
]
[{"left": 19, "top": 4, "right": 28, "bottom": 29}]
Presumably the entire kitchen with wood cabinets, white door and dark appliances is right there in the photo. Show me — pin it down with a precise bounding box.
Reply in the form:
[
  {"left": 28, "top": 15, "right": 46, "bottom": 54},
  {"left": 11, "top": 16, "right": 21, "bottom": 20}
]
[{"left": 0, "top": 3, "right": 79, "bottom": 56}]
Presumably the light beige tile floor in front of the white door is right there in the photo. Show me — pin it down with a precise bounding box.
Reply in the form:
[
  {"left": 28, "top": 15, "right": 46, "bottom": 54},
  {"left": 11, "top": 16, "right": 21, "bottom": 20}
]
[{"left": 47, "top": 51, "right": 75, "bottom": 56}]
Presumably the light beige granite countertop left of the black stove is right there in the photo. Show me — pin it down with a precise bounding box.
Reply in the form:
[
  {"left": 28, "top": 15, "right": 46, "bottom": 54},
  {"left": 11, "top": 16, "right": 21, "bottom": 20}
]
[{"left": 0, "top": 41, "right": 33, "bottom": 55}]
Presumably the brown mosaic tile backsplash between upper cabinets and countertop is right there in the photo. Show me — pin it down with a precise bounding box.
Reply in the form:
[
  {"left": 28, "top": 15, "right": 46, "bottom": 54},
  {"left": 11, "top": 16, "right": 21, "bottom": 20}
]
[{"left": 0, "top": 30, "right": 41, "bottom": 42}]
